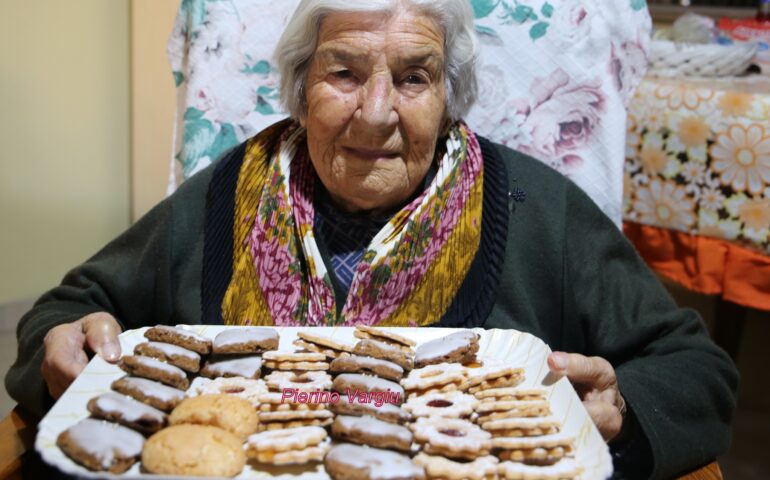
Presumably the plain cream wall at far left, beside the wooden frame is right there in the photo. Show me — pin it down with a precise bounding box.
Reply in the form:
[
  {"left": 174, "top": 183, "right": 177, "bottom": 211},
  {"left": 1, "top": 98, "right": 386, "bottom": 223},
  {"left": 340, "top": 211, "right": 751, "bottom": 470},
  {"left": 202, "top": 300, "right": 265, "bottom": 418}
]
[{"left": 0, "top": 0, "right": 129, "bottom": 303}]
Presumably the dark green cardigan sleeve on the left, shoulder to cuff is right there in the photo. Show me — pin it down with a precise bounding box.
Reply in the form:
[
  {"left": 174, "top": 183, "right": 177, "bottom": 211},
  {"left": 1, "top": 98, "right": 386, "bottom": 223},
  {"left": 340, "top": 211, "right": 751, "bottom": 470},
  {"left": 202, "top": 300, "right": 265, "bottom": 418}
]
[{"left": 5, "top": 166, "right": 210, "bottom": 416}]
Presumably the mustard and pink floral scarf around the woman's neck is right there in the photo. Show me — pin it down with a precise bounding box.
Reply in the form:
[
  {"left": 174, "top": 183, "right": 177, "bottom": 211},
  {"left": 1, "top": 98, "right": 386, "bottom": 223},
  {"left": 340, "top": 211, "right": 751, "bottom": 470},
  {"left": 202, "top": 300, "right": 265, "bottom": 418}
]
[{"left": 222, "top": 122, "right": 483, "bottom": 326}]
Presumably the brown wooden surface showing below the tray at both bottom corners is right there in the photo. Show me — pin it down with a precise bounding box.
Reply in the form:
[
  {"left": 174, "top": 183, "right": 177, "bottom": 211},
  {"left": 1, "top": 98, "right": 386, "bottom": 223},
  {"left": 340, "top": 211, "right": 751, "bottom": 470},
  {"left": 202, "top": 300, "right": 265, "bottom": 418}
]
[{"left": 0, "top": 408, "right": 722, "bottom": 480}]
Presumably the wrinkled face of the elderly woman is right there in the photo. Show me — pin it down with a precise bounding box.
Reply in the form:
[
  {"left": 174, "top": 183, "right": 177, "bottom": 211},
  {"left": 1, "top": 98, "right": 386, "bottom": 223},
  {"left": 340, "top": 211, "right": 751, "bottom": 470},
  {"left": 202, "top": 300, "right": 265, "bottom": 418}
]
[{"left": 302, "top": 7, "right": 446, "bottom": 212}]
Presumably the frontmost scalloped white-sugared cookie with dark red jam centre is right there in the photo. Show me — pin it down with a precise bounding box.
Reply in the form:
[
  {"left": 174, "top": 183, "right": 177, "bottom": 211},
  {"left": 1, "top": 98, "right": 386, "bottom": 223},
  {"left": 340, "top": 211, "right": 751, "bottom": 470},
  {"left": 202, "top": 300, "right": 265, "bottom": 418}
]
[{"left": 411, "top": 417, "right": 492, "bottom": 460}]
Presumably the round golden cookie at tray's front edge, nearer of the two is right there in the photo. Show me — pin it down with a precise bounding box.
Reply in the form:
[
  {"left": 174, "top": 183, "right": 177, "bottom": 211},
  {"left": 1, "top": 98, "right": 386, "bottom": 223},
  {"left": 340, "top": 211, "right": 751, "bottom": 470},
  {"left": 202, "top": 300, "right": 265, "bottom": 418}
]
[{"left": 142, "top": 426, "right": 243, "bottom": 477}]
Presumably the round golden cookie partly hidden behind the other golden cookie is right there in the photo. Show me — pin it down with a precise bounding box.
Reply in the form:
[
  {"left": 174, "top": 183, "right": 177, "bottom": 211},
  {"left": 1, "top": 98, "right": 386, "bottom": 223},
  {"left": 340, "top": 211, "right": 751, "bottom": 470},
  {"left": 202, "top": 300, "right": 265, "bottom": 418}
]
[{"left": 168, "top": 394, "right": 258, "bottom": 441}]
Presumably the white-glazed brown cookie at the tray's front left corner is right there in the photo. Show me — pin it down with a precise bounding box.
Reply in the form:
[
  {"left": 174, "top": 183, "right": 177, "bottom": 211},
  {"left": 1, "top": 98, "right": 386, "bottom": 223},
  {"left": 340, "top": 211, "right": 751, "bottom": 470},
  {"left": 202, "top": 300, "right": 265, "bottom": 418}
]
[{"left": 56, "top": 418, "right": 144, "bottom": 474}]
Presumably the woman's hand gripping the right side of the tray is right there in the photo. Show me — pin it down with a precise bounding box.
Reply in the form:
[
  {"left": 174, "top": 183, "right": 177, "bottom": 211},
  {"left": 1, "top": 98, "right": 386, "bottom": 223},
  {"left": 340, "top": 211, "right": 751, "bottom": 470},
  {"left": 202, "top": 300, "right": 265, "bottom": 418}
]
[{"left": 548, "top": 352, "right": 626, "bottom": 442}]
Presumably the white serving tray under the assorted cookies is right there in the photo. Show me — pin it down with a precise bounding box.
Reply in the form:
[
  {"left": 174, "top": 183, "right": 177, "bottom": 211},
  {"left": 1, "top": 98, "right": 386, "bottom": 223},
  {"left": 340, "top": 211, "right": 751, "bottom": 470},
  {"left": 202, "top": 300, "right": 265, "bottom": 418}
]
[{"left": 35, "top": 325, "right": 612, "bottom": 480}]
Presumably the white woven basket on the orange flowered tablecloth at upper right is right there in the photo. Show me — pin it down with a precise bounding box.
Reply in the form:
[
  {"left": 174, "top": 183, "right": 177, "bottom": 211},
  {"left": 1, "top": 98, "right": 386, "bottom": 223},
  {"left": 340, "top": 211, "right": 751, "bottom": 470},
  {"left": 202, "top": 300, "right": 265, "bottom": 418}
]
[{"left": 649, "top": 40, "right": 759, "bottom": 77}]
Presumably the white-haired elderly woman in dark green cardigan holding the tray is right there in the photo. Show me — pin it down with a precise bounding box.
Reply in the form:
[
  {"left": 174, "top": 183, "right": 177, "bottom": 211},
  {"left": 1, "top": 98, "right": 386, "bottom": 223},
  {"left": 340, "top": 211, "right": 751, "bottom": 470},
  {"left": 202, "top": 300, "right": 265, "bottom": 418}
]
[{"left": 6, "top": 0, "right": 736, "bottom": 477}]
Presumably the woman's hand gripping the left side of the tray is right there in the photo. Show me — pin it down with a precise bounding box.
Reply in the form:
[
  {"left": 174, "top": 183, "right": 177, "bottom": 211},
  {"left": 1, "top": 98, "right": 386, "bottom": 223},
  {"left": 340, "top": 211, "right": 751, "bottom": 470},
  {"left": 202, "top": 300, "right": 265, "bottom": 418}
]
[{"left": 40, "top": 312, "right": 121, "bottom": 398}]
